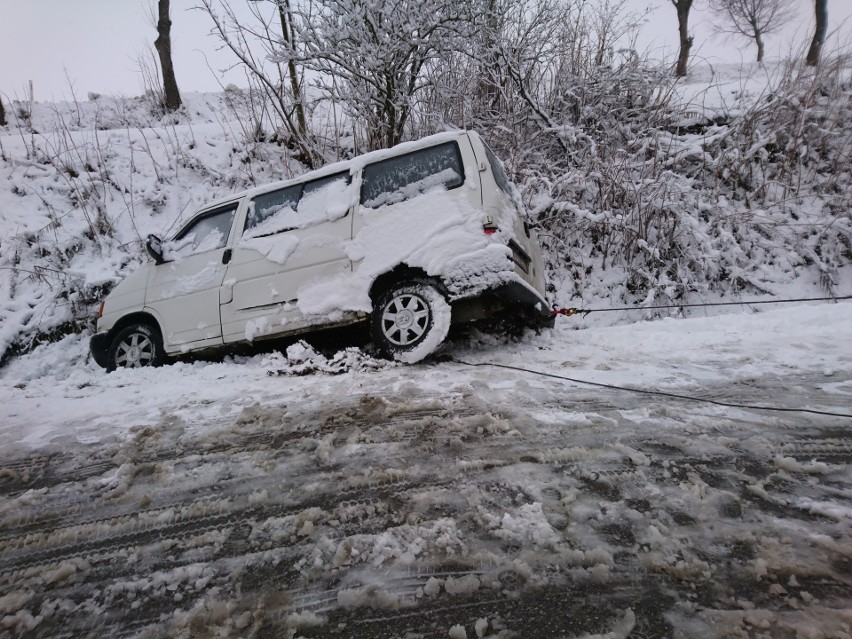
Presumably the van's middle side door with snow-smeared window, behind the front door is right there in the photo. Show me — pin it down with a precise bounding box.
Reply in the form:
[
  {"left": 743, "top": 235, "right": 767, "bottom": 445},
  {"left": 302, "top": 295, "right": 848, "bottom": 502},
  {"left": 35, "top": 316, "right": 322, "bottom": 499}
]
[{"left": 221, "top": 171, "right": 353, "bottom": 343}]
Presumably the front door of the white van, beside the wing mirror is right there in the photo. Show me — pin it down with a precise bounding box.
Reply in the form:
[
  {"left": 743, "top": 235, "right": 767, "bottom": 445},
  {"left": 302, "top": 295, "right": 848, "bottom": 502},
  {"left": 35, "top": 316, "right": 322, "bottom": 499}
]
[{"left": 145, "top": 202, "right": 239, "bottom": 352}]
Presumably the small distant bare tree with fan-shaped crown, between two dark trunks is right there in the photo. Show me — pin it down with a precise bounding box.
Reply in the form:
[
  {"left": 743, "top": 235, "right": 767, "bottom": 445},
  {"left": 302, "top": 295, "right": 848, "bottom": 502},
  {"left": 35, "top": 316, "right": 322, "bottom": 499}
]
[{"left": 710, "top": 0, "right": 797, "bottom": 64}]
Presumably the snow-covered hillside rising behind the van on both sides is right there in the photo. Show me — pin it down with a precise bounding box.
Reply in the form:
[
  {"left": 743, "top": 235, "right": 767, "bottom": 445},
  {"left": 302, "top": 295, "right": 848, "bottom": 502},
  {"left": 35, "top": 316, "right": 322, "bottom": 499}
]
[{"left": 0, "top": 64, "right": 852, "bottom": 370}]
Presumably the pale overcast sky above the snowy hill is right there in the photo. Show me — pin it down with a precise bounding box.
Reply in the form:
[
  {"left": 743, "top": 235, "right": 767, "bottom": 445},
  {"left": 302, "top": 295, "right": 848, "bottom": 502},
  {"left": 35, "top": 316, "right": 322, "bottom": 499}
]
[{"left": 0, "top": 0, "right": 852, "bottom": 100}]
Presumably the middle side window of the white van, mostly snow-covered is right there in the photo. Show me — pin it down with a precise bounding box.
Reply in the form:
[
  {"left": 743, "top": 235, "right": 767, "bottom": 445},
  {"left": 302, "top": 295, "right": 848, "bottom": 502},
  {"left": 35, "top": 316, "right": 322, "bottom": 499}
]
[{"left": 243, "top": 171, "right": 350, "bottom": 238}]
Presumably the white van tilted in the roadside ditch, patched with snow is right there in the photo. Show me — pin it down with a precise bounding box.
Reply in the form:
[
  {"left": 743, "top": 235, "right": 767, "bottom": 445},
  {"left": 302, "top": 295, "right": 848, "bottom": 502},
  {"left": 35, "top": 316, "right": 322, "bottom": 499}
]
[{"left": 91, "top": 131, "right": 552, "bottom": 370}]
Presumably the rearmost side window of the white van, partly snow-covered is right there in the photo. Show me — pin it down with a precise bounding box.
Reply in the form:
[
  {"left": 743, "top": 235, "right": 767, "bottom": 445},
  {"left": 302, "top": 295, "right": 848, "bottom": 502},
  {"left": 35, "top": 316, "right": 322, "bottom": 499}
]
[{"left": 361, "top": 142, "right": 464, "bottom": 209}]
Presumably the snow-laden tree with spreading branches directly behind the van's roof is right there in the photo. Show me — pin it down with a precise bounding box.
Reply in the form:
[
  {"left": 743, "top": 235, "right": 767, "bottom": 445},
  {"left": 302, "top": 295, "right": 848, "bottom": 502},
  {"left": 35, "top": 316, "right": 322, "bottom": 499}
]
[{"left": 286, "top": 0, "right": 472, "bottom": 149}]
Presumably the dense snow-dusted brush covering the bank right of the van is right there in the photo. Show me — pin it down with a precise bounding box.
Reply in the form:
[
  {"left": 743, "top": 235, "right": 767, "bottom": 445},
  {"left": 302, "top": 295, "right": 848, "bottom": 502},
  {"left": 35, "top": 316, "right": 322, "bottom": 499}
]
[{"left": 524, "top": 55, "right": 852, "bottom": 302}]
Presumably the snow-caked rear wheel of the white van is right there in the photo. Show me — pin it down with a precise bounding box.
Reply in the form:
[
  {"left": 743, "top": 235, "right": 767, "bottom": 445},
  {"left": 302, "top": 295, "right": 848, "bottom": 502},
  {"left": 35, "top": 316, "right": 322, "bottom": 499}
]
[{"left": 370, "top": 280, "right": 452, "bottom": 364}]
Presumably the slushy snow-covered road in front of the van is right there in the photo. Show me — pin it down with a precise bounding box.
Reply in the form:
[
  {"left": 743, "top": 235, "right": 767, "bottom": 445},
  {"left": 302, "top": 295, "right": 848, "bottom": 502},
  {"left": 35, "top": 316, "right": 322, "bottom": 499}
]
[{"left": 0, "top": 305, "right": 852, "bottom": 638}]
